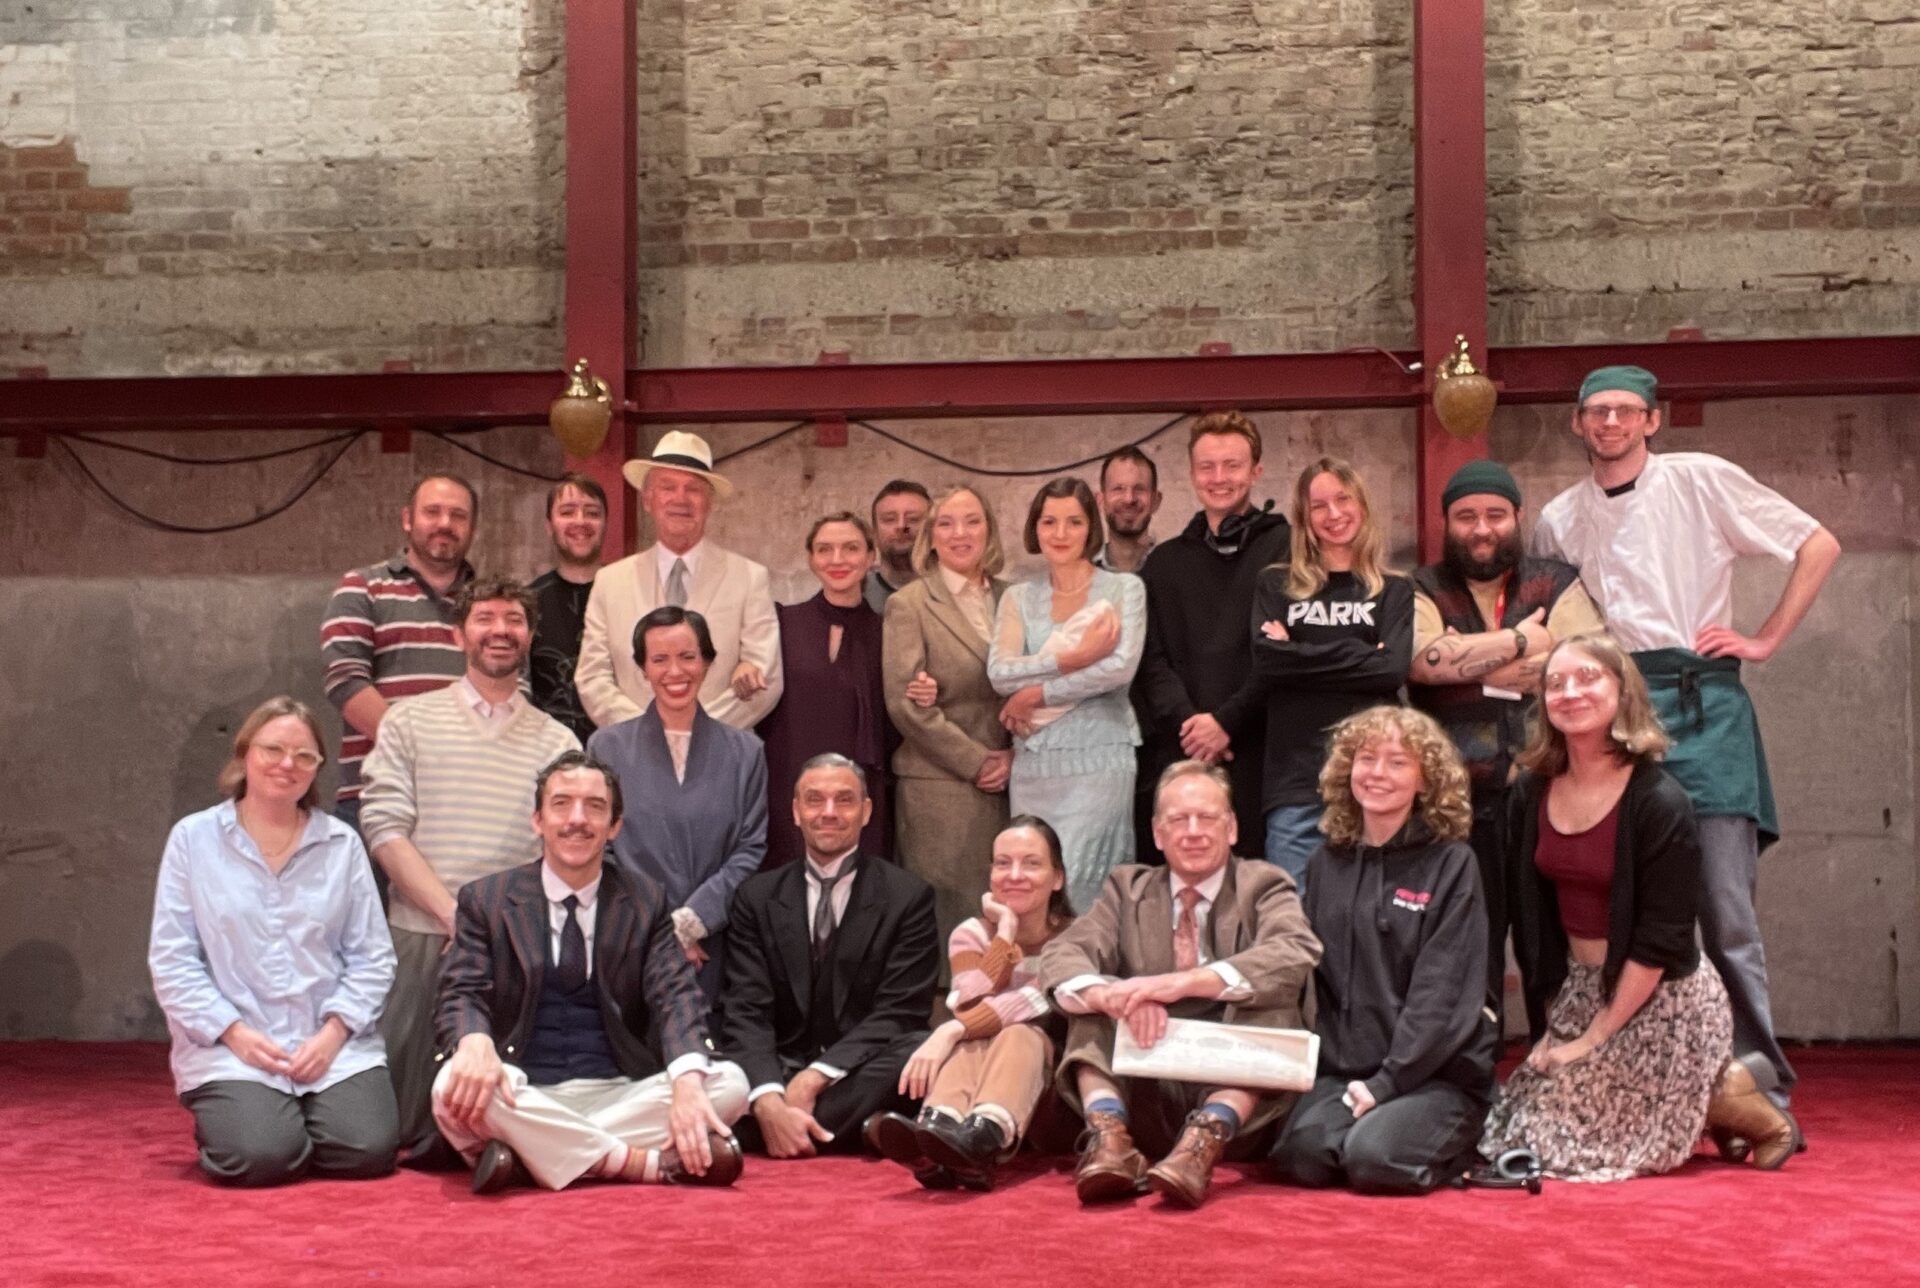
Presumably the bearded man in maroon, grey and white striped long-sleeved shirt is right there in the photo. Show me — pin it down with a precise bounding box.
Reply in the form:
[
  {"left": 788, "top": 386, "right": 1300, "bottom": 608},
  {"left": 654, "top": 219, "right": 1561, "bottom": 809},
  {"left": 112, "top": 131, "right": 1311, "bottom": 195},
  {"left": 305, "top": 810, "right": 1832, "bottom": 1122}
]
[{"left": 321, "top": 474, "right": 480, "bottom": 836}]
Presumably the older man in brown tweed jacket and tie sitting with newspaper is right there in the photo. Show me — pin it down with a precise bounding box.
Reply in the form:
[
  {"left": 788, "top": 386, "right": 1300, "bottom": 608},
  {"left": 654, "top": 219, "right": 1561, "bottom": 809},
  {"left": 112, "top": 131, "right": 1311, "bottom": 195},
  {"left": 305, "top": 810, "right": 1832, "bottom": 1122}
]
[{"left": 1041, "top": 760, "right": 1321, "bottom": 1207}]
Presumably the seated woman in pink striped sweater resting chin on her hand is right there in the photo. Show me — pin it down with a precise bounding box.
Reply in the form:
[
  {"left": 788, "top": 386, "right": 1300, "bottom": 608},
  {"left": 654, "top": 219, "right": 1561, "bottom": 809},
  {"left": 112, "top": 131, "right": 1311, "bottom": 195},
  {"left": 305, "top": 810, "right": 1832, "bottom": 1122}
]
[{"left": 872, "top": 814, "right": 1073, "bottom": 1190}]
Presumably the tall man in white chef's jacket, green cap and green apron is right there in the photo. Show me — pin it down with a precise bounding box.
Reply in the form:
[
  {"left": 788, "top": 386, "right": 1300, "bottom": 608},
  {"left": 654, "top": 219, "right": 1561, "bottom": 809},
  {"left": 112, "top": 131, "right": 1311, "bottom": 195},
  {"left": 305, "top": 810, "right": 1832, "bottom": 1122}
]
[{"left": 1532, "top": 367, "right": 1839, "bottom": 1106}]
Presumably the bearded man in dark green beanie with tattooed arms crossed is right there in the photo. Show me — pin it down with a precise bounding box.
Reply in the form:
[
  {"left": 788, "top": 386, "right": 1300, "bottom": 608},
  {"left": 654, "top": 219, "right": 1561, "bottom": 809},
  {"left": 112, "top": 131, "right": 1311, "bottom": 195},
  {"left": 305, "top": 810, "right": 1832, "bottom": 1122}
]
[{"left": 1407, "top": 461, "right": 1601, "bottom": 1015}]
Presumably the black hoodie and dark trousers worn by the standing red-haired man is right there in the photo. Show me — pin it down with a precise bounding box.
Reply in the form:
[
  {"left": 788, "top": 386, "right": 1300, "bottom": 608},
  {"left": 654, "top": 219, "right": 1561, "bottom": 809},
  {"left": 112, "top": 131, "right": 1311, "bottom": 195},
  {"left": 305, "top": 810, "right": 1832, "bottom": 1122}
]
[{"left": 1133, "top": 503, "right": 1292, "bottom": 850}]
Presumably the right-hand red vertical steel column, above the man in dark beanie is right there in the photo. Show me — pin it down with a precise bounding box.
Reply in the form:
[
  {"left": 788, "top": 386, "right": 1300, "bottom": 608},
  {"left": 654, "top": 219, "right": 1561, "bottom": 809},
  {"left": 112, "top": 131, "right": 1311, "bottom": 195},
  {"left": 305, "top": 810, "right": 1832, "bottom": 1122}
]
[{"left": 1413, "top": 0, "right": 1486, "bottom": 562}]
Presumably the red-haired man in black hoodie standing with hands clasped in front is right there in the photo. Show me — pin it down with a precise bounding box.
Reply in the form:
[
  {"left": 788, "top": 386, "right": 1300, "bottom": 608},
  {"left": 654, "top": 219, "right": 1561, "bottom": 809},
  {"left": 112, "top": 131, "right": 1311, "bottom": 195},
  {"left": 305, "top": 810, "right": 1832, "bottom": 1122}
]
[{"left": 1133, "top": 411, "right": 1292, "bottom": 856}]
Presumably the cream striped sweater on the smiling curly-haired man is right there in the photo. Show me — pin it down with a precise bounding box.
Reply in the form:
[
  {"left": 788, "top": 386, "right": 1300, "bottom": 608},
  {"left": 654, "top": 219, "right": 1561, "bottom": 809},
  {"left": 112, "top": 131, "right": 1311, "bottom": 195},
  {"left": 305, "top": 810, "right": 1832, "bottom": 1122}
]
[{"left": 361, "top": 685, "right": 580, "bottom": 935}]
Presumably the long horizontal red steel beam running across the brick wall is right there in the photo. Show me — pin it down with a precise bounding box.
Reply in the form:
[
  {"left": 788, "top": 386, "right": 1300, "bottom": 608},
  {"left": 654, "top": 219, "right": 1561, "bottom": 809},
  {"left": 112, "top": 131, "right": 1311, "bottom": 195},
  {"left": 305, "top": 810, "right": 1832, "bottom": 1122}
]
[{"left": 0, "top": 336, "right": 1920, "bottom": 434}]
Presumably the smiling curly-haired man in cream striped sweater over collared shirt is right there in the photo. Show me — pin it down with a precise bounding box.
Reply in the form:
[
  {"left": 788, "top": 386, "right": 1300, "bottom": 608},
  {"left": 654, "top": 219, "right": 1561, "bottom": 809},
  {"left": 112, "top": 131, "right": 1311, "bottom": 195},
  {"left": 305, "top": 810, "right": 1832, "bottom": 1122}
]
[{"left": 361, "top": 578, "right": 580, "bottom": 1163}]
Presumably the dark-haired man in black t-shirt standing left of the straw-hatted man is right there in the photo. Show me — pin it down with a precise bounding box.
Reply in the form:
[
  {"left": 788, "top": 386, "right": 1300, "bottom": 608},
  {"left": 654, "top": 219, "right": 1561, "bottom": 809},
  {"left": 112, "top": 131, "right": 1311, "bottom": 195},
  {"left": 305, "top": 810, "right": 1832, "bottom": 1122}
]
[{"left": 526, "top": 474, "right": 607, "bottom": 743}]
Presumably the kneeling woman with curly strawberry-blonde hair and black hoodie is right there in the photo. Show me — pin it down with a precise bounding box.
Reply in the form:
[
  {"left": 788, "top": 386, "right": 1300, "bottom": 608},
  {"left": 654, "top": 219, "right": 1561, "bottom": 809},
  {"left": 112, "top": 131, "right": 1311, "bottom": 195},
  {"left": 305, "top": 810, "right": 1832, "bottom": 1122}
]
[{"left": 1271, "top": 706, "right": 1500, "bottom": 1194}]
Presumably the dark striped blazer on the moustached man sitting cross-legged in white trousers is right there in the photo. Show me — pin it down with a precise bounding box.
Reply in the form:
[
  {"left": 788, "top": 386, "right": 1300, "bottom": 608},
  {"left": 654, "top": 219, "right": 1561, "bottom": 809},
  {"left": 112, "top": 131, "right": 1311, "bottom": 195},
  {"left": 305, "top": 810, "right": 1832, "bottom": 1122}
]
[{"left": 434, "top": 862, "right": 710, "bottom": 1079}]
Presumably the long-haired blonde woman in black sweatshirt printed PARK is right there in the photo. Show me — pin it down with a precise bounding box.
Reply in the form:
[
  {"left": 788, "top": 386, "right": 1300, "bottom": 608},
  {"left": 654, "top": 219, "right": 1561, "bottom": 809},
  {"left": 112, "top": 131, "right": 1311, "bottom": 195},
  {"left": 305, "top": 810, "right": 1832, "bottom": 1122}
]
[{"left": 1252, "top": 457, "right": 1413, "bottom": 881}]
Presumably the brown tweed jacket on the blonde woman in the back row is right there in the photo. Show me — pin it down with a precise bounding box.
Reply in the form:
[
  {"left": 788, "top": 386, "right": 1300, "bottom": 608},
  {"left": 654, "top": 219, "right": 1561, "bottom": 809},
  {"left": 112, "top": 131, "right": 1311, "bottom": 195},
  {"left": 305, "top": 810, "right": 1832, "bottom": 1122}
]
[{"left": 879, "top": 574, "right": 1012, "bottom": 783}]
